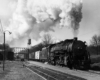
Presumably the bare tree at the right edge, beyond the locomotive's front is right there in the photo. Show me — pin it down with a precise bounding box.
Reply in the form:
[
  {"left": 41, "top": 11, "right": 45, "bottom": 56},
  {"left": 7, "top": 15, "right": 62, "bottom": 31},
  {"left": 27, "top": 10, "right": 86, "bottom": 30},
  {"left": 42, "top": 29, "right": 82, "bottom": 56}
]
[{"left": 90, "top": 35, "right": 100, "bottom": 55}]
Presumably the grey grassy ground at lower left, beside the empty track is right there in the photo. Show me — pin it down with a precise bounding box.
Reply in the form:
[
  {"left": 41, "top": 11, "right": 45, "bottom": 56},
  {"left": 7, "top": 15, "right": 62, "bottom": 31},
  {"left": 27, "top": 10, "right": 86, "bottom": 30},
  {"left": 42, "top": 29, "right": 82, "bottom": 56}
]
[{"left": 0, "top": 61, "right": 43, "bottom": 80}]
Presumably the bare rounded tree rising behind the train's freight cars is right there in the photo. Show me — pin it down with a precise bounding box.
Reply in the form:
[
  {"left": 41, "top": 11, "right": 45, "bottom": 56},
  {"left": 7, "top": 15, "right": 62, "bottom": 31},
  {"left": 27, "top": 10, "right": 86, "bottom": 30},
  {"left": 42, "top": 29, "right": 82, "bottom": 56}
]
[{"left": 42, "top": 34, "right": 53, "bottom": 46}]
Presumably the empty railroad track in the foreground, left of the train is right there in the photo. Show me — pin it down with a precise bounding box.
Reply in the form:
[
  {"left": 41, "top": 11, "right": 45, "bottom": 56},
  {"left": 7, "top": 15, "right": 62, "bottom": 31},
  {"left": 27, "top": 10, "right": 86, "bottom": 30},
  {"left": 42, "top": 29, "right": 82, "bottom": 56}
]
[{"left": 29, "top": 66, "right": 86, "bottom": 80}]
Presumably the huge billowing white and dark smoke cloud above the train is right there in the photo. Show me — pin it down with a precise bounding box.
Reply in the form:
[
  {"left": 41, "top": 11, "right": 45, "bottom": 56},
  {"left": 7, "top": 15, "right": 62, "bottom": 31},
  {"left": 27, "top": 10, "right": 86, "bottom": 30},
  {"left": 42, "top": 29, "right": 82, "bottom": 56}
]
[{"left": 8, "top": 0, "right": 82, "bottom": 46}]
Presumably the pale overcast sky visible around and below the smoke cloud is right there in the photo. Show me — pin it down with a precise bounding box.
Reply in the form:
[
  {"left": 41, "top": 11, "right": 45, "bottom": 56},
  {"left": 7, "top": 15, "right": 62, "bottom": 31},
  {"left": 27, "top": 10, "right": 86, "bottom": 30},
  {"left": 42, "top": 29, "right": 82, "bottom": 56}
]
[{"left": 0, "top": 0, "right": 100, "bottom": 46}]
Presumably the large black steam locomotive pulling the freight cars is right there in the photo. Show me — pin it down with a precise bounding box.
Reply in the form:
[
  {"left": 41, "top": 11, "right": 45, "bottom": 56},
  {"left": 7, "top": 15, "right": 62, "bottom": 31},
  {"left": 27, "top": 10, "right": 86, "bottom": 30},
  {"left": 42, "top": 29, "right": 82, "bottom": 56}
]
[{"left": 49, "top": 37, "right": 90, "bottom": 69}]
